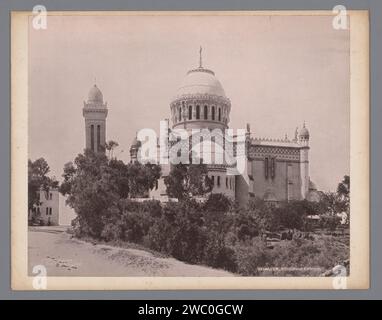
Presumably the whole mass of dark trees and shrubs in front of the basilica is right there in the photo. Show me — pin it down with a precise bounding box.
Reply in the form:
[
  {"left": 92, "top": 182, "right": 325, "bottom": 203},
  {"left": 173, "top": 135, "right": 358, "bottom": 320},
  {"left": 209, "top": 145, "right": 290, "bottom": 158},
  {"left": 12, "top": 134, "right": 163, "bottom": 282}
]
[{"left": 65, "top": 160, "right": 349, "bottom": 276}]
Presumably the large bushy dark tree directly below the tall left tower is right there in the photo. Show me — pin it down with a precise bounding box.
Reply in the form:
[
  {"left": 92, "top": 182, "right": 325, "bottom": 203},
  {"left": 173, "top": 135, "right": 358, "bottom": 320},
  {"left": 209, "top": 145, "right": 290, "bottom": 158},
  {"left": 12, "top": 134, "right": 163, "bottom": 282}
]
[{"left": 60, "top": 149, "right": 160, "bottom": 238}]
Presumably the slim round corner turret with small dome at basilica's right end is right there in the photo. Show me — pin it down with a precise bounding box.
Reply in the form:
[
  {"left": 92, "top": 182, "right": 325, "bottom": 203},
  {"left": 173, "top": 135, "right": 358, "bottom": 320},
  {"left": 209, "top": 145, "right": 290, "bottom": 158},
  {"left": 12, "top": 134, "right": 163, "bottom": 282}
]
[{"left": 298, "top": 122, "right": 309, "bottom": 199}]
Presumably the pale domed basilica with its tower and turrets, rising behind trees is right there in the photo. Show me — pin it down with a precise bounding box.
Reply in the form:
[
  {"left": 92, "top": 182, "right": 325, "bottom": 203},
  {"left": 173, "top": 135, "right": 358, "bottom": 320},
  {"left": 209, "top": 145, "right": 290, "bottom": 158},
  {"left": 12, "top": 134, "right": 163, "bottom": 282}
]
[{"left": 83, "top": 51, "right": 319, "bottom": 204}]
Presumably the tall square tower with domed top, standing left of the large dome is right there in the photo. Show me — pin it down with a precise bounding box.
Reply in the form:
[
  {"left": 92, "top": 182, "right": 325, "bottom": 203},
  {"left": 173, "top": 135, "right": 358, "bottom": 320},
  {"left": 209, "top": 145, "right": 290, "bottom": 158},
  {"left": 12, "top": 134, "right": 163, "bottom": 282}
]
[{"left": 82, "top": 85, "right": 108, "bottom": 152}]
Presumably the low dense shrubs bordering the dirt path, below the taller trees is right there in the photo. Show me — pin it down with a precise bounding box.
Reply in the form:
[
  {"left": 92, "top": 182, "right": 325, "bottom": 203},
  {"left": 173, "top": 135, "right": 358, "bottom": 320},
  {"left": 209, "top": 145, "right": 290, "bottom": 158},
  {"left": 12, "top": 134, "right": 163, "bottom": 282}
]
[{"left": 73, "top": 190, "right": 348, "bottom": 276}]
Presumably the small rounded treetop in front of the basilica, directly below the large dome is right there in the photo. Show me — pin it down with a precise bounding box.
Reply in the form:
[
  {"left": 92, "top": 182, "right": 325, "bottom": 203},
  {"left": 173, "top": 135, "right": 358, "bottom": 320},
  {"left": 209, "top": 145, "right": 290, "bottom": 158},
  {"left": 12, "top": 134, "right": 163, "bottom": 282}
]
[{"left": 164, "top": 163, "right": 212, "bottom": 200}]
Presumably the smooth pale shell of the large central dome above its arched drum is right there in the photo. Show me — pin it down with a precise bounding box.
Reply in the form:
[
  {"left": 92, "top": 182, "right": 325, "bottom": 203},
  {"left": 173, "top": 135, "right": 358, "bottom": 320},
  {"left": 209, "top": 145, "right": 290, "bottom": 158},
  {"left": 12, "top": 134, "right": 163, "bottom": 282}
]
[{"left": 176, "top": 67, "right": 226, "bottom": 97}]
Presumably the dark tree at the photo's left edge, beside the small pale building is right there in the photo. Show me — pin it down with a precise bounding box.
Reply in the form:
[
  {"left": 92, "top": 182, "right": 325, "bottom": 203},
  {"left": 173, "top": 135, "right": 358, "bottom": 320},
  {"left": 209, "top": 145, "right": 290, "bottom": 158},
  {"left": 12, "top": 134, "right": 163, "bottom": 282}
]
[{"left": 28, "top": 158, "right": 58, "bottom": 211}]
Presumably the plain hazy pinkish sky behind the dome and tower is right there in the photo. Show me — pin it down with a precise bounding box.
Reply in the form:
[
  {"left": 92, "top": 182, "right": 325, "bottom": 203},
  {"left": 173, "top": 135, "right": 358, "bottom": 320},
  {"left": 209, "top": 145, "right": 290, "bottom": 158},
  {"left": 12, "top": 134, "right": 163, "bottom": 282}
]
[{"left": 29, "top": 16, "right": 350, "bottom": 190}]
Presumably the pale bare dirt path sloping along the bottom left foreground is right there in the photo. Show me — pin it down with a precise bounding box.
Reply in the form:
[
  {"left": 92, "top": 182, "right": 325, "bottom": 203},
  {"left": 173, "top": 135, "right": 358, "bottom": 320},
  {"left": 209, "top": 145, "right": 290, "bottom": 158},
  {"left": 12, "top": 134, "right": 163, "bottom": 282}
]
[{"left": 28, "top": 227, "right": 234, "bottom": 277}]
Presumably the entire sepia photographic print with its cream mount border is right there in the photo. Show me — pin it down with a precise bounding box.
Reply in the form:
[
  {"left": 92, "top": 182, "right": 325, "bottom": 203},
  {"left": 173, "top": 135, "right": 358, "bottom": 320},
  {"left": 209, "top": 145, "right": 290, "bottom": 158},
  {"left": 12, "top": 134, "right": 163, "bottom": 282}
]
[{"left": 11, "top": 10, "right": 369, "bottom": 290}]
